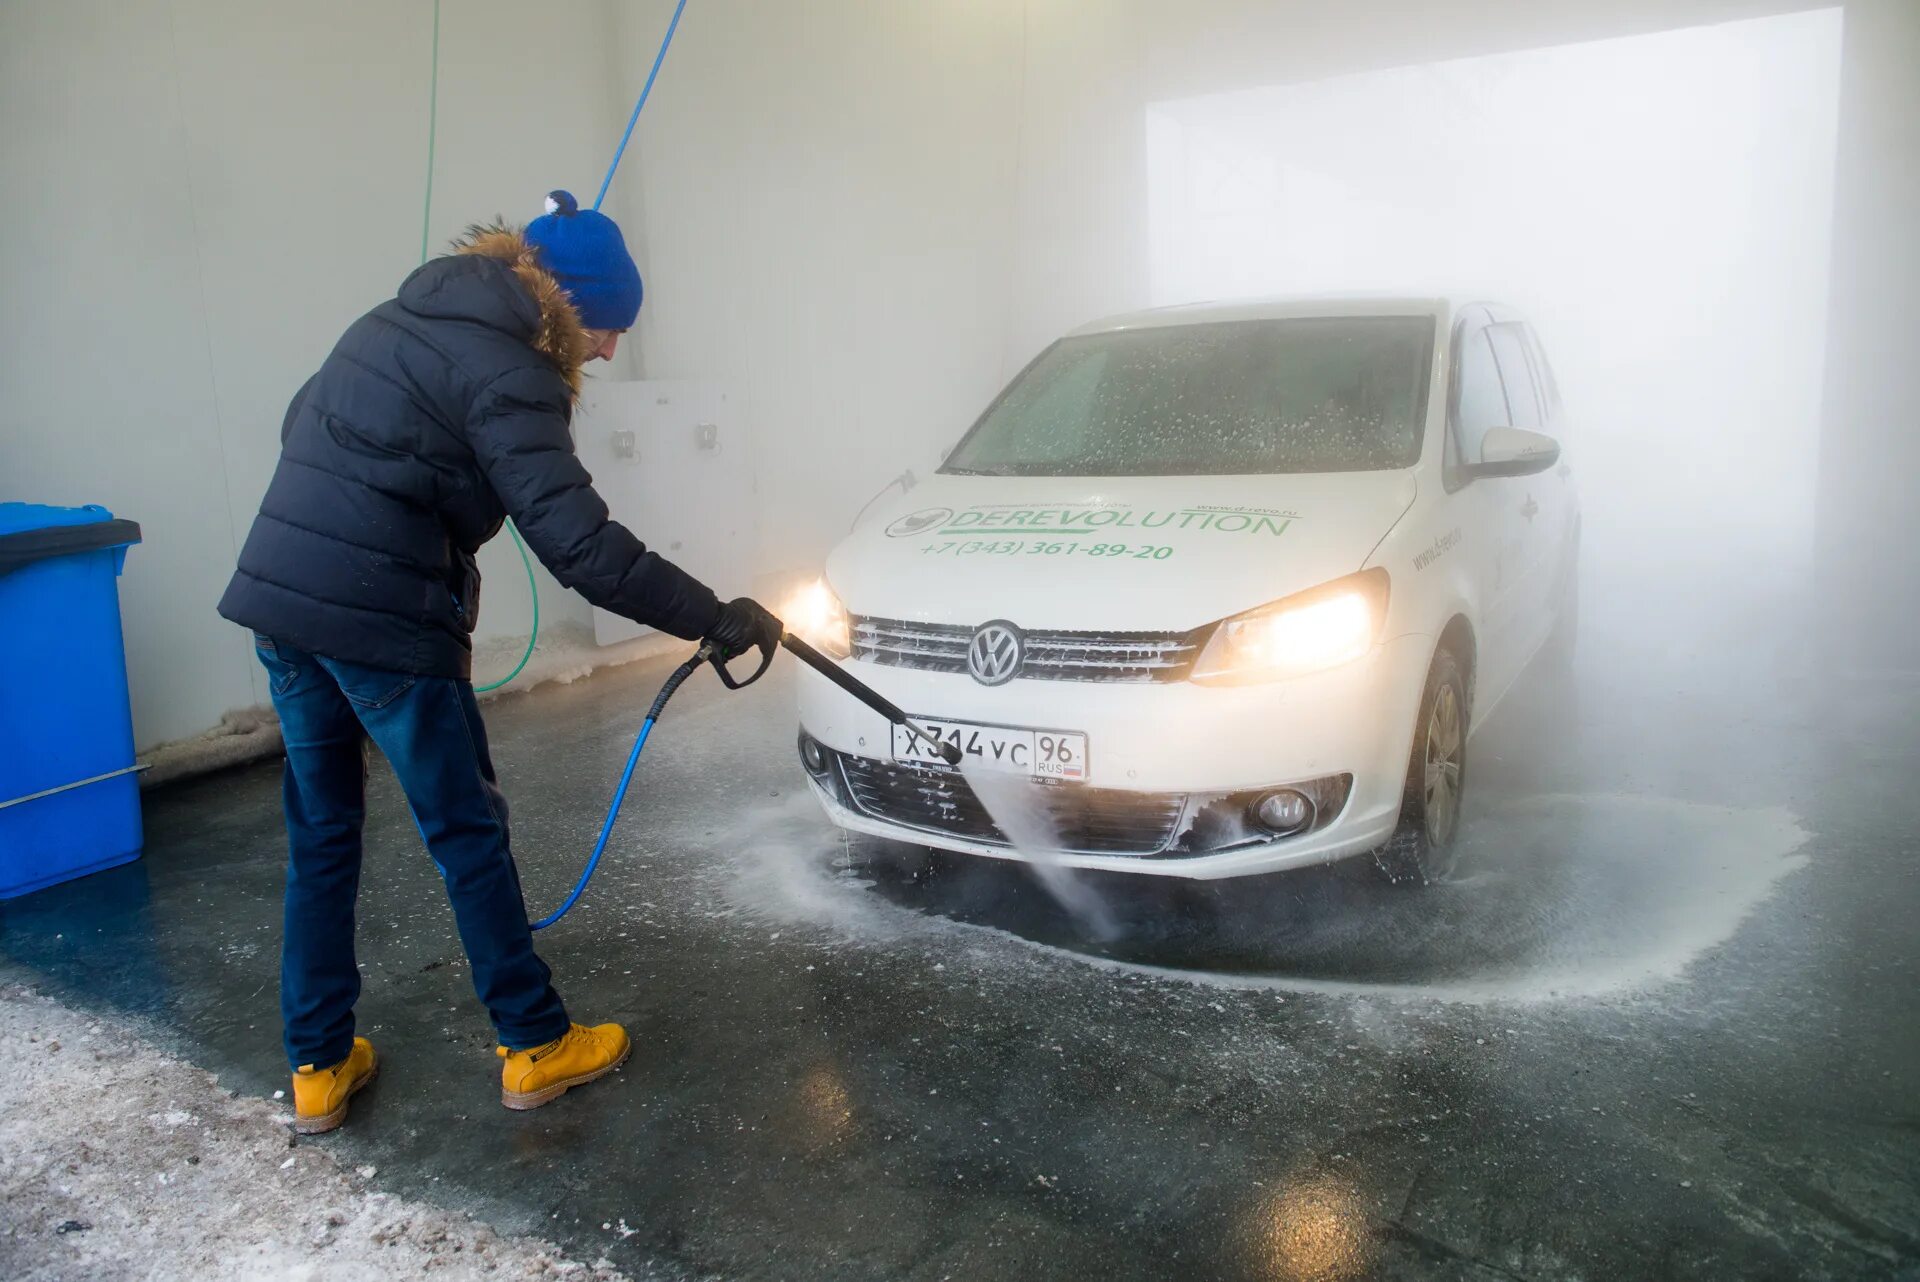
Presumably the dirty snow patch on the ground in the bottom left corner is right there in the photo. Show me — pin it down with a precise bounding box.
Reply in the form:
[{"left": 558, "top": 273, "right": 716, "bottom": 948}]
[{"left": 0, "top": 986, "right": 622, "bottom": 1282}]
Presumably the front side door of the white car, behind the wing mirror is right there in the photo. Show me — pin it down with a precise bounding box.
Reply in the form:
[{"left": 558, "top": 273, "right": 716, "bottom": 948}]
[{"left": 1446, "top": 307, "right": 1530, "bottom": 710}]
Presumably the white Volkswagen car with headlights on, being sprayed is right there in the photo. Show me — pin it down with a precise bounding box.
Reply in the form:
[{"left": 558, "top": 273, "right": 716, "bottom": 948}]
[{"left": 789, "top": 299, "right": 1580, "bottom": 885}]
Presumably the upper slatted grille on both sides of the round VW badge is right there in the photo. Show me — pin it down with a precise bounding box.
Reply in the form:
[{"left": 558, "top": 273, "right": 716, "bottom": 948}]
[{"left": 852, "top": 618, "right": 1202, "bottom": 683}]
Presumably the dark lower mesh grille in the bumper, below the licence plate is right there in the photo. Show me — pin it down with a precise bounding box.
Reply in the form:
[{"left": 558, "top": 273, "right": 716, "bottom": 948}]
[{"left": 835, "top": 754, "right": 1187, "bottom": 856}]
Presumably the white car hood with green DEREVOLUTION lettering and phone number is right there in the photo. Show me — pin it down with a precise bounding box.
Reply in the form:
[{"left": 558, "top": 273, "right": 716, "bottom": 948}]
[{"left": 828, "top": 472, "right": 1415, "bottom": 631}]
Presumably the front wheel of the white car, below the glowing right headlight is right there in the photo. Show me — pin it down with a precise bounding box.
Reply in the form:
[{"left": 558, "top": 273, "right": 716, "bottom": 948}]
[{"left": 1373, "top": 651, "right": 1469, "bottom": 887}]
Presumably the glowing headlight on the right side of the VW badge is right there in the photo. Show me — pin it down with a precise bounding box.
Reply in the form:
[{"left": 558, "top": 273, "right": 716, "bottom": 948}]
[{"left": 1192, "top": 570, "right": 1386, "bottom": 685}]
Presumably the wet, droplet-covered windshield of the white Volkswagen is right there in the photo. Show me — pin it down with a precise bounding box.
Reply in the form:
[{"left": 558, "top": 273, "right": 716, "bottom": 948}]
[{"left": 941, "top": 317, "right": 1434, "bottom": 476}]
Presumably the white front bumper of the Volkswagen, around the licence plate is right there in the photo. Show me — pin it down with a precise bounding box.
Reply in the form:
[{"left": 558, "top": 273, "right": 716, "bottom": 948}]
[{"left": 799, "top": 635, "right": 1432, "bottom": 879}]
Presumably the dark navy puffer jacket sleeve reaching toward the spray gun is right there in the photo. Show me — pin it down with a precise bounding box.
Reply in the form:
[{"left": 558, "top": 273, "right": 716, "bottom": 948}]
[{"left": 467, "top": 368, "right": 720, "bottom": 639}]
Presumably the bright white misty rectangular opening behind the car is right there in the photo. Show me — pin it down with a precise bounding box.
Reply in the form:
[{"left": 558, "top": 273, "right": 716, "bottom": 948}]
[{"left": 1148, "top": 10, "right": 1841, "bottom": 587}]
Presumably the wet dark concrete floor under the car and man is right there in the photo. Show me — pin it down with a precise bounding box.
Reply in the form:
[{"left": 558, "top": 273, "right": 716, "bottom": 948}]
[{"left": 0, "top": 587, "right": 1920, "bottom": 1282}]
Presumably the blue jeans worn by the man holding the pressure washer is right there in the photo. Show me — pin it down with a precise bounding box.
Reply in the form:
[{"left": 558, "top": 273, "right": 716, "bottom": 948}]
[{"left": 253, "top": 635, "right": 568, "bottom": 1067}]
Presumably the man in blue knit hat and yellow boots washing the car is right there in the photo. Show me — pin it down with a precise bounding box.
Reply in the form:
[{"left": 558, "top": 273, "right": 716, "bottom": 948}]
[{"left": 219, "top": 192, "right": 780, "bottom": 1134}]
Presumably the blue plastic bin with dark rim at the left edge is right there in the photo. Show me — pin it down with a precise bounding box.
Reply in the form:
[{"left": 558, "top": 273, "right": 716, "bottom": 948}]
[{"left": 0, "top": 503, "right": 140, "bottom": 900}]
